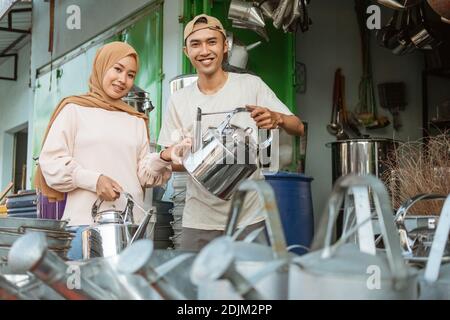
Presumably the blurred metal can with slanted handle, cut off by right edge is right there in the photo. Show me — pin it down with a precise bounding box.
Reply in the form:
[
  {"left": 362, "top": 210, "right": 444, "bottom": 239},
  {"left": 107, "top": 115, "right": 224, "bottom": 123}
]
[{"left": 420, "top": 196, "right": 450, "bottom": 300}]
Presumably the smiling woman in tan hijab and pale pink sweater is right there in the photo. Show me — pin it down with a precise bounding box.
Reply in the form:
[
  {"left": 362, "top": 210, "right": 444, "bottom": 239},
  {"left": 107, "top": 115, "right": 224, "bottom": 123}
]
[{"left": 35, "top": 42, "right": 190, "bottom": 259}]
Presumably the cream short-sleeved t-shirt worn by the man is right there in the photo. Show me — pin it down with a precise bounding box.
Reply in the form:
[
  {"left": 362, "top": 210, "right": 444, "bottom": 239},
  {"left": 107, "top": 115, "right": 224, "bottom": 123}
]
[{"left": 158, "top": 72, "right": 292, "bottom": 230}]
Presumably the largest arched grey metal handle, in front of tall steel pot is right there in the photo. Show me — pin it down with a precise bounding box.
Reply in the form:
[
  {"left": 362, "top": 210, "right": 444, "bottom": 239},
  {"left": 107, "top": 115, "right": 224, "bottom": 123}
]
[{"left": 311, "top": 174, "right": 408, "bottom": 289}]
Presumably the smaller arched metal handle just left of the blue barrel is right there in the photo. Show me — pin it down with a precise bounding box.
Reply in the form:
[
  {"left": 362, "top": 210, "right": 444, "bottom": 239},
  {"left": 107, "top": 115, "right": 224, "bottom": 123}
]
[{"left": 225, "top": 180, "right": 288, "bottom": 259}]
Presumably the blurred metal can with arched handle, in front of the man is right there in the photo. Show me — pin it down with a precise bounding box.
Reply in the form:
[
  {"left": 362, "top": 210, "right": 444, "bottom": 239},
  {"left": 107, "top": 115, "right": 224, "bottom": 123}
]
[{"left": 191, "top": 180, "right": 288, "bottom": 300}]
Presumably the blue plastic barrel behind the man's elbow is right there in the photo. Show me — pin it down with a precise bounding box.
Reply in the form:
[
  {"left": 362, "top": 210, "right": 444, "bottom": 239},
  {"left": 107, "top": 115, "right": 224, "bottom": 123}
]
[{"left": 265, "top": 172, "right": 314, "bottom": 254}]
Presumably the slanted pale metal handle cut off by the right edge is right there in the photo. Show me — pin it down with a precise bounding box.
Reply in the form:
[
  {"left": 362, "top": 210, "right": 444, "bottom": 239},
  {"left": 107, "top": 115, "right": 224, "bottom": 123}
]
[{"left": 424, "top": 195, "right": 450, "bottom": 282}]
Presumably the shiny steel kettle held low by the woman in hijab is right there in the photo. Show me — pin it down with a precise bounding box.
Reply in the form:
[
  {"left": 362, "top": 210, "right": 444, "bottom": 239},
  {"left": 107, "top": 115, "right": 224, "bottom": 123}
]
[{"left": 81, "top": 193, "right": 153, "bottom": 259}]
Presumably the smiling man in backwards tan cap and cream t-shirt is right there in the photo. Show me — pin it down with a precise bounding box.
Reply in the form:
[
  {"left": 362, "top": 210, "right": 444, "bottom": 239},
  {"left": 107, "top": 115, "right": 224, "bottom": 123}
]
[{"left": 158, "top": 14, "right": 303, "bottom": 250}]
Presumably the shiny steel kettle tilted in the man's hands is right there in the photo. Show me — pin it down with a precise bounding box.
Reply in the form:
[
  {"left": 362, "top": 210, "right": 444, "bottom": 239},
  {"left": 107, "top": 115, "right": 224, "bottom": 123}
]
[{"left": 183, "top": 108, "right": 272, "bottom": 200}]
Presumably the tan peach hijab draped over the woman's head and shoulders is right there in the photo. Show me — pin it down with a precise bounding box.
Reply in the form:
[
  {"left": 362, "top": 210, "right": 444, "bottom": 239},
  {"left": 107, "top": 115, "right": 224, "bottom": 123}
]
[{"left": 34, "top": 41, "right": 148, "bottom": 202}]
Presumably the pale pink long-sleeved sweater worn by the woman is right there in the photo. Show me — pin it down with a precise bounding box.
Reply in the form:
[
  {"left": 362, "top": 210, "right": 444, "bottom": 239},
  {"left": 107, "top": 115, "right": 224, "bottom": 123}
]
[{"left": 39, "top": 104, "right": 171, "bottom": 226}]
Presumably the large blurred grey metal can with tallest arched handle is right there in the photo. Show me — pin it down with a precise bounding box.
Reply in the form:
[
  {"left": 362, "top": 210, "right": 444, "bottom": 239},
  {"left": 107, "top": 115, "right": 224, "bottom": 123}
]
[{"left": 289, "top": 175, "right": 418, "bottom": 300}]
